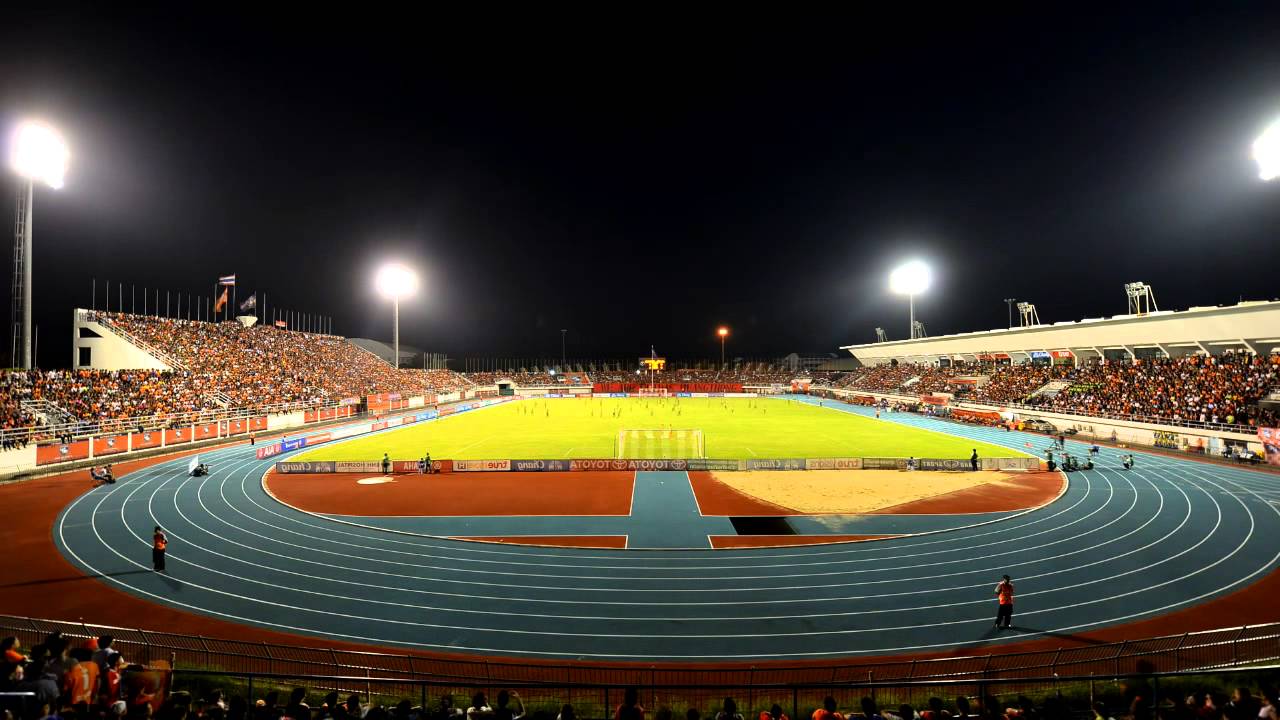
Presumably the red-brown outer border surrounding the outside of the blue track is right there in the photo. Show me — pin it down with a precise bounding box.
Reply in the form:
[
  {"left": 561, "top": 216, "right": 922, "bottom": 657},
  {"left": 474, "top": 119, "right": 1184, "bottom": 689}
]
[{"left": 0, "top": 456, "right": 1280, "bottom": 667}]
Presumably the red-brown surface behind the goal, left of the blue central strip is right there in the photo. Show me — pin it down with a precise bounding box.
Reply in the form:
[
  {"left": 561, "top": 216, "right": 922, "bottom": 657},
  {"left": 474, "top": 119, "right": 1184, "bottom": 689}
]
[{"left": 266, "top": 473, "right": 635, "bottom": 516}]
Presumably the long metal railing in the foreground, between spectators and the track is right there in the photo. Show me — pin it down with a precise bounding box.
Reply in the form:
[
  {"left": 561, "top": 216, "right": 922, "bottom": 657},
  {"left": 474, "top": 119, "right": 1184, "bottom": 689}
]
[{"left": 0, "top": 615, "right": 1280, "bottom": 685}]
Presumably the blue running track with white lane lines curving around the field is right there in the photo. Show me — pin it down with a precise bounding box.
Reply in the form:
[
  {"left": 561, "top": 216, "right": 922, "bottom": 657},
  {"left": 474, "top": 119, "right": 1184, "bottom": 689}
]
[{"left": 54, "top": 398, "right": 1280, "bottom": 661}]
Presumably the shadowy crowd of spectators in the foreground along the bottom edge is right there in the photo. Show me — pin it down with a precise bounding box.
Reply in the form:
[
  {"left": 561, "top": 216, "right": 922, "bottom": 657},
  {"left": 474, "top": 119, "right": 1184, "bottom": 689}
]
[{"left": 0, "top": 650, "right": 1280, "bottom": 720}]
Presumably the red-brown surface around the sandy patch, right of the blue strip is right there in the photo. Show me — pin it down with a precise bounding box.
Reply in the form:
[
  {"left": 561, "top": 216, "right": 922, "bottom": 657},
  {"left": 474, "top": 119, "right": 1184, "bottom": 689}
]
[{"left": 689, "top": 470, "right": 1066, "bottom": 516}]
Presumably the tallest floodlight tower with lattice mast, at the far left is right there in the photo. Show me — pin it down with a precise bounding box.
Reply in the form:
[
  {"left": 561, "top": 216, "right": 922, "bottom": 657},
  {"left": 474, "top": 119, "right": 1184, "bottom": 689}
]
[{"left": 9, "top": 120, "right": 70, "bottom": 370}]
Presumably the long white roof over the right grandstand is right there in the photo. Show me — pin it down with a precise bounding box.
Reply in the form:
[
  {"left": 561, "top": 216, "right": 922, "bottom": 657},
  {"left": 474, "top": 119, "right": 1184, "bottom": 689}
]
[{"left": 841, "top": 301, "right": 1280, "bottom": 365}]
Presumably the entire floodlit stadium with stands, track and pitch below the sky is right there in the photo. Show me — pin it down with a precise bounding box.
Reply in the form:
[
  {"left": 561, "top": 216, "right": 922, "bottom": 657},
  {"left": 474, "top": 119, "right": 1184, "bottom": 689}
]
[{"left": 0, "top": 8, "right": 1280, "bottom": 720}]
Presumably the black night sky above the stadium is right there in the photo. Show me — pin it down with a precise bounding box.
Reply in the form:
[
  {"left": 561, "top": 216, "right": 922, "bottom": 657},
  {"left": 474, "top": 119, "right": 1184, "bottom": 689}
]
[{"left": 0, "top": 3, "right": 1280, "bottom": 366}]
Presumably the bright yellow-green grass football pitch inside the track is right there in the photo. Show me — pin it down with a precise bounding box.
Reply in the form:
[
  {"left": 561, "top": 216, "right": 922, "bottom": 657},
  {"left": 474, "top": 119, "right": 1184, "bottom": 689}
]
[{"left": 296, "top": 397, "right": 1021, "bottom": 460}]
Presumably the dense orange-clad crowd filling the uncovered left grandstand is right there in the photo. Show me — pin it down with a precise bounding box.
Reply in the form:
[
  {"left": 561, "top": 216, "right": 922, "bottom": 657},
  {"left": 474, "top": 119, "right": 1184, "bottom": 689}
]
[{"left": 0, "top": 314, "right": 470, "bottom": 435}]
